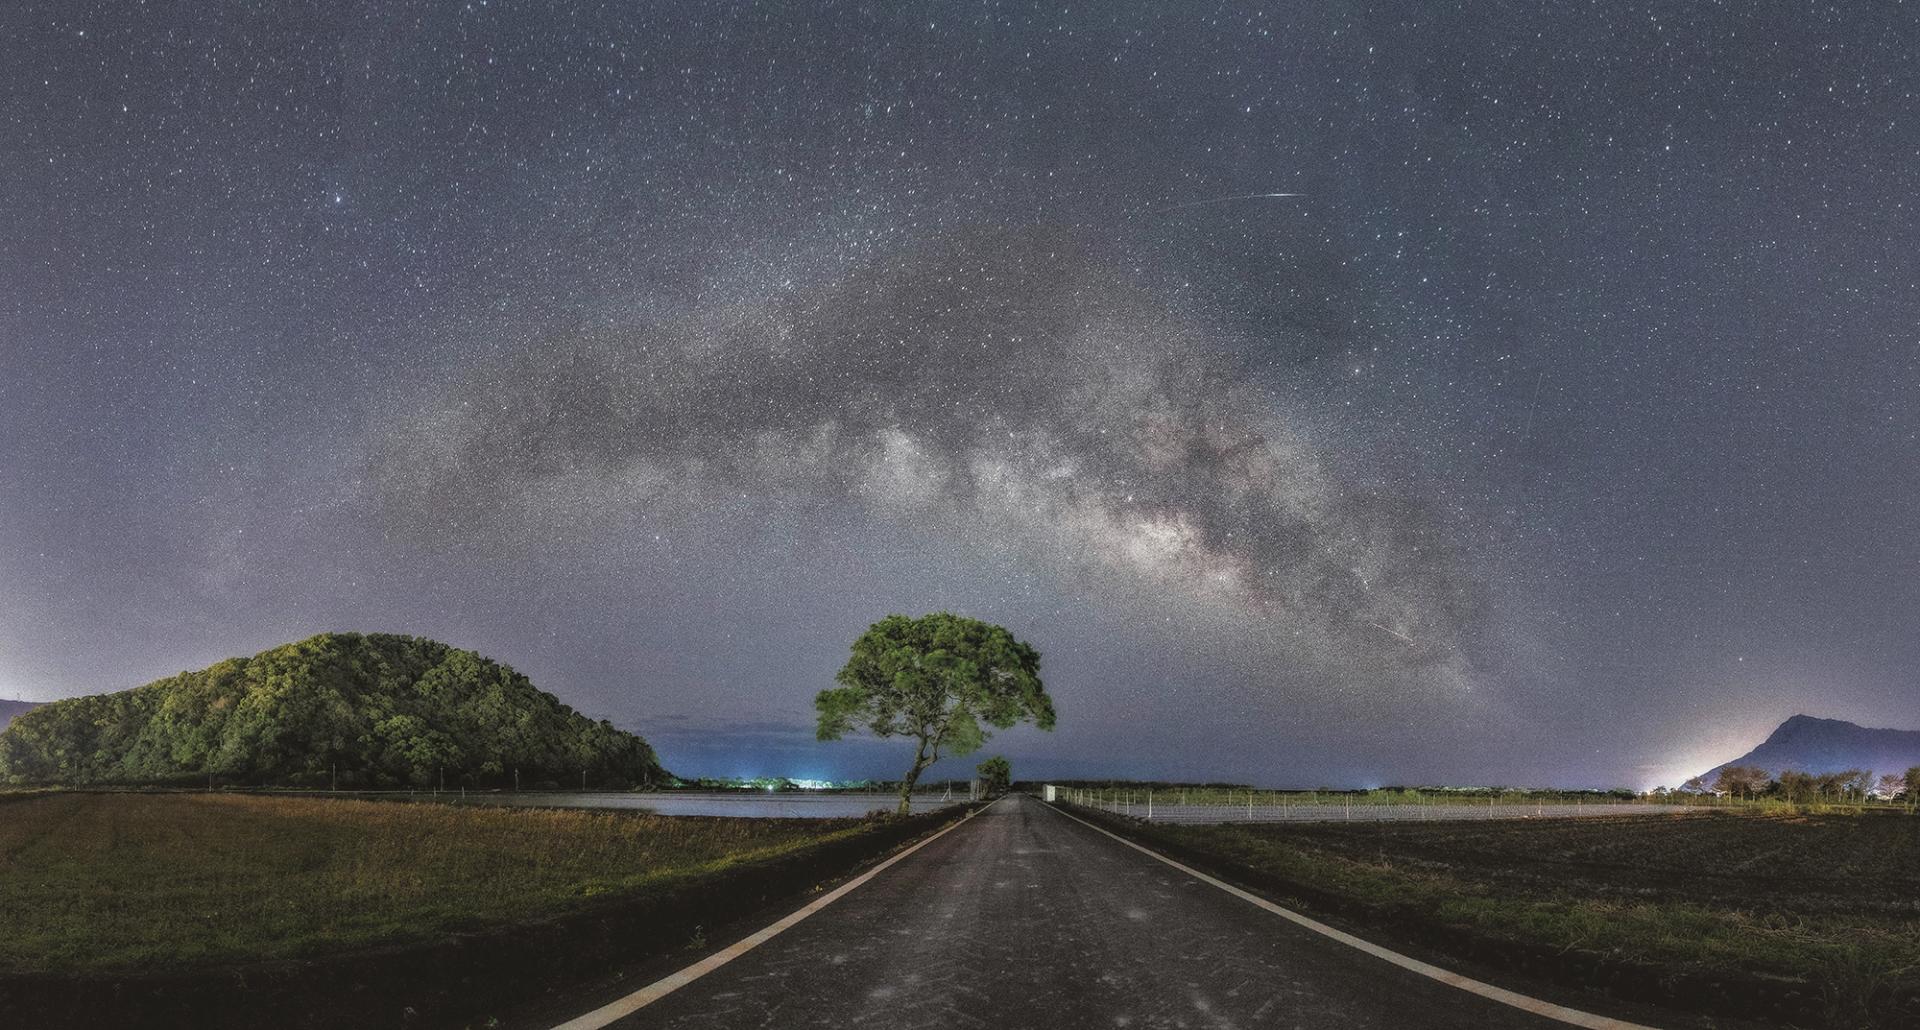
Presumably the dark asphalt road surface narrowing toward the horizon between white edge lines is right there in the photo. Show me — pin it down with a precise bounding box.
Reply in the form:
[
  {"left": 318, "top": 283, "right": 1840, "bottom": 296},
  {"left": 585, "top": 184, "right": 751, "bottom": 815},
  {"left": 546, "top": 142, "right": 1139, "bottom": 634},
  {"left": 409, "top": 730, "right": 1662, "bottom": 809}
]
[{"left": 583, "top": 796, "right": 1589, "bottom": 1030}]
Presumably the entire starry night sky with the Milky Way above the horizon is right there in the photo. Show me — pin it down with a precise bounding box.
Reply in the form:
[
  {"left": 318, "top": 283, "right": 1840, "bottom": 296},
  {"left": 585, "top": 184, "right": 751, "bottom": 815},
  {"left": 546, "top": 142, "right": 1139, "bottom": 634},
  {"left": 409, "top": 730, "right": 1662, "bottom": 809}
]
[{"left": 0, "top": 0, "right": 1920, "bottom": 786}]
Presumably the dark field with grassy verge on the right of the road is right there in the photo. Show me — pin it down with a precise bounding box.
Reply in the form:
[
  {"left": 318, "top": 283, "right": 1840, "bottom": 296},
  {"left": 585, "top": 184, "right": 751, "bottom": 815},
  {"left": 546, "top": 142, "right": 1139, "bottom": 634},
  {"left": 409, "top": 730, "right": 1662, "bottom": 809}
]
[{"left": 1150, "top": 813, "right": 1920, "bottom": 1026}]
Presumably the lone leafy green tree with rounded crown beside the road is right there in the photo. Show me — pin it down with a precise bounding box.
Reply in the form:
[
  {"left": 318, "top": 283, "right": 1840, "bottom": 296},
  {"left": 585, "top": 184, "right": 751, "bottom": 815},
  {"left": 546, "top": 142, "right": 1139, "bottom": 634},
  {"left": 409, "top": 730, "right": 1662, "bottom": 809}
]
[{"left": 814, "top": 611, "right": 1054, "bottom": 815}]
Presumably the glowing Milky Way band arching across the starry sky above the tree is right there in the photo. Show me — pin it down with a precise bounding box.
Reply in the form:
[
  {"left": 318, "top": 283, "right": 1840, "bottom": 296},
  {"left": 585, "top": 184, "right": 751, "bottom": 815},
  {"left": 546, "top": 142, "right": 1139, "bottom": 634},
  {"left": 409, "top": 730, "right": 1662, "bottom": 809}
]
[{"left": 372, "top": 234, "right": 1478, "bottom": 684}]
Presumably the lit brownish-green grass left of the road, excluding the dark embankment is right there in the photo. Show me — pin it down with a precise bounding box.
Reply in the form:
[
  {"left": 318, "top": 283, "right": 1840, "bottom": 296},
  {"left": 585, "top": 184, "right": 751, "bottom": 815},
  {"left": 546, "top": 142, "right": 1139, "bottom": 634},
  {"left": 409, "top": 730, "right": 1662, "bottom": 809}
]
[{"left": 0, "top": 794, "right": 866, "bottom": 972}]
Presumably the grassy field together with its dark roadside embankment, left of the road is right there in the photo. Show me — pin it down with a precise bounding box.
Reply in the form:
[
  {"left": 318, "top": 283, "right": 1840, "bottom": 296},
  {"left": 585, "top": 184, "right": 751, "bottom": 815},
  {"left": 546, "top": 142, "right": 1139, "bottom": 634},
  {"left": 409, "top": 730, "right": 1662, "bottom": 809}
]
[{"left": 0, "top": 794, "right": 958, "bottom": 1026}]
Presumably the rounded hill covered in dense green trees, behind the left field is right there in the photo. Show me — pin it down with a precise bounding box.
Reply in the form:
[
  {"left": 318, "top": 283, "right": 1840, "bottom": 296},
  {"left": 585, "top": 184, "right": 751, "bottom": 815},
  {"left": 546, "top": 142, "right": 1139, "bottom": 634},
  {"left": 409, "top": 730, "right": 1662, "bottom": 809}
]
[{"left": 0, "top": 632, "right": 666, "bottom": 788}]
